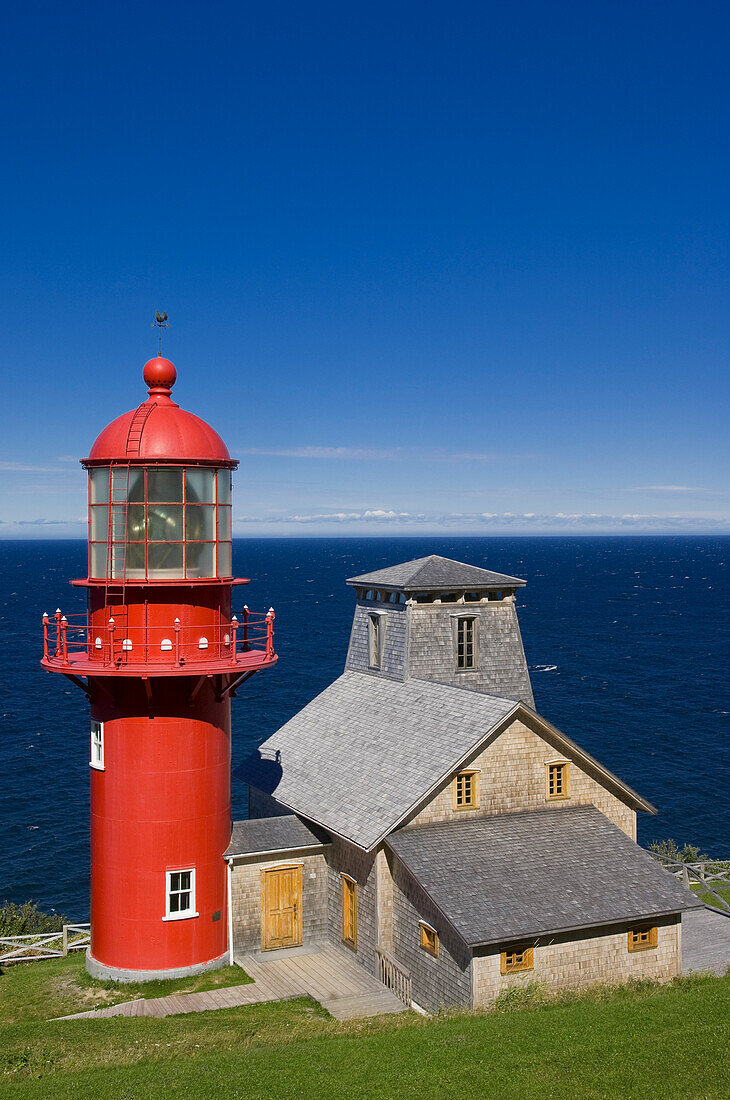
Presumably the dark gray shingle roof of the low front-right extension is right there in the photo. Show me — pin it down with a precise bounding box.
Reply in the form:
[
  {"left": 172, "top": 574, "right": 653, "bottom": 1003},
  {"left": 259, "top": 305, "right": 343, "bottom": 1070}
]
[{"left": 387, "top": 806, "right": 700, "bottom": 946}]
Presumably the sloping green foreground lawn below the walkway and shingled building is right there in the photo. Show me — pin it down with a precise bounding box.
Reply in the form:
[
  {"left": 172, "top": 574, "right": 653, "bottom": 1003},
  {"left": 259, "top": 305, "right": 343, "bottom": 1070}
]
[{"left": 0, "top": 960, "right": 730, "bottom": 1100}]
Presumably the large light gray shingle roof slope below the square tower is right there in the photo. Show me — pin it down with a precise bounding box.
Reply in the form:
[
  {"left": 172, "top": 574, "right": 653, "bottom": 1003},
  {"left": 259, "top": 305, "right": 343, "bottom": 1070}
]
[{"left": 236, "top": 672, "right": 518, "bottom": 850}]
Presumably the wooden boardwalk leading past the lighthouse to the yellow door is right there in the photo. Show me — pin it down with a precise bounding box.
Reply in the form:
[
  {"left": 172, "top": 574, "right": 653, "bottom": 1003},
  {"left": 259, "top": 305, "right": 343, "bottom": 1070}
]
[{"left": 59, "top": 945, "right": 406, "bottom": 1020}]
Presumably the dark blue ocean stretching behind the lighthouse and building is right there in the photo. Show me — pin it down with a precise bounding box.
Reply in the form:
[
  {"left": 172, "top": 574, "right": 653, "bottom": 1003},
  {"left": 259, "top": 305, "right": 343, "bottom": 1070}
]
[{"left": 0, "top": 537, "right": 730, "bottom": 920}]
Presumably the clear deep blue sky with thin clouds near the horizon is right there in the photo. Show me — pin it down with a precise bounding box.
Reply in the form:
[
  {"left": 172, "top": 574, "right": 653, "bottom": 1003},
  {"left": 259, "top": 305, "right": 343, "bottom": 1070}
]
[{"left": 0, "top": 0, "right": 730, "bottom": 538}]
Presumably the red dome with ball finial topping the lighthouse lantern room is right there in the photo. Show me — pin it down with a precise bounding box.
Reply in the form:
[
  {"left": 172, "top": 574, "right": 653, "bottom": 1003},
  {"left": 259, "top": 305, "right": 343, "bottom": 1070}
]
[{"left": 84, "top": 358, "right": 237, "bottom": 466}]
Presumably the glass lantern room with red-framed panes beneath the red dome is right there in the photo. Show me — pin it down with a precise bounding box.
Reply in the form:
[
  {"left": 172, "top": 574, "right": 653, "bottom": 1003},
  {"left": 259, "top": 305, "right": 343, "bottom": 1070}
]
[{"left": 89, "top": 466, "right": 232, "bottom": 580}]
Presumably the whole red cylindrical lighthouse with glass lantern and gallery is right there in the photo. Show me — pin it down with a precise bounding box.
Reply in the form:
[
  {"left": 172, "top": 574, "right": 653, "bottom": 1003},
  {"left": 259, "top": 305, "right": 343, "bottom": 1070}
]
[{"left": 42, "top": 358, "right": 276, "bottom": 980}]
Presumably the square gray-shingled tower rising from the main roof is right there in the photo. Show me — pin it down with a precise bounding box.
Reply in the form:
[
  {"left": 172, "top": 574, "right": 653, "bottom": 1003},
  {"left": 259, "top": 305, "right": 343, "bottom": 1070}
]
[{"left": 346, "top": 554, "right": 534, "bottom": 706}]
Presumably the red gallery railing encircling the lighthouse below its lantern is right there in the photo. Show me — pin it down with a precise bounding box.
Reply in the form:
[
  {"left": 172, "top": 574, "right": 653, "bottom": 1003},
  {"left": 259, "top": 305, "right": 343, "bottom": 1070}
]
[{"left": 43, "top": 607, "right": 275, "bottom": 669}]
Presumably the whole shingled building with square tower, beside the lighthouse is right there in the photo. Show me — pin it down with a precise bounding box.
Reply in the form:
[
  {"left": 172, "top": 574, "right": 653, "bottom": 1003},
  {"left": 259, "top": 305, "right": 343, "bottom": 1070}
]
[{"left": 226, "top": 556, "right": 697, "bottom": 1010}]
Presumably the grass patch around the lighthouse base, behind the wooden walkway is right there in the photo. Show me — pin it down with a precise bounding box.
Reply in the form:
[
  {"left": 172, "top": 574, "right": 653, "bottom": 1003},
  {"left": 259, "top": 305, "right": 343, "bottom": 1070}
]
[{"left": 0, "top": 952, "right": 252, "bottom": 1025}]
